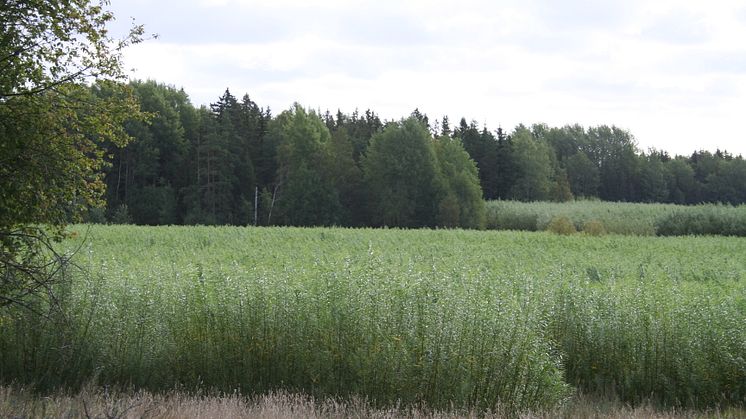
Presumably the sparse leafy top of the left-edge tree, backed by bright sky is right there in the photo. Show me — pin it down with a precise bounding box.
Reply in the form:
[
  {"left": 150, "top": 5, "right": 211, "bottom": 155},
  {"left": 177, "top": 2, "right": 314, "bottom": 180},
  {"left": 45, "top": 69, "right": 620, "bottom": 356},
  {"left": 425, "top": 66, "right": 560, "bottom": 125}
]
[{"left": 0, "top": 0, "right": 143, "bottom": 102}]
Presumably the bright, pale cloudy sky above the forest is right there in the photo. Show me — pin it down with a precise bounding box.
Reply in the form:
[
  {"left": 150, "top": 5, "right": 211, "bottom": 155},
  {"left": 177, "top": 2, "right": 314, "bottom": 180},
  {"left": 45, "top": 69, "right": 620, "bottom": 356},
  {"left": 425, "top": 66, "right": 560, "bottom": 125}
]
[{"left": 109, "top": 0, "right": 746, "bottom": 156}]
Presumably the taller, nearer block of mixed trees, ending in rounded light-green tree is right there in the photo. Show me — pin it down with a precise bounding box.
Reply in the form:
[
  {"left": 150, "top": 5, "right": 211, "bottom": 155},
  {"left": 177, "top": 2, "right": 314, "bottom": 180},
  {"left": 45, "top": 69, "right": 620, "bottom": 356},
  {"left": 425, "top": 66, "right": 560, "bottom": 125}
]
[{"left": 99, "top": 81, "right": 485, "bottom": 228}]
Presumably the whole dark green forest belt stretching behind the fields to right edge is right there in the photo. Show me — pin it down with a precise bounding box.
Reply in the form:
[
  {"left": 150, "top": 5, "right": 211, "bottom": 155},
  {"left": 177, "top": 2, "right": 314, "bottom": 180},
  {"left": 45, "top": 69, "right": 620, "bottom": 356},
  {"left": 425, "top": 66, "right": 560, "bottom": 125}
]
[{"left": 94, "top": 81, "right": 746, "bottom": 228}]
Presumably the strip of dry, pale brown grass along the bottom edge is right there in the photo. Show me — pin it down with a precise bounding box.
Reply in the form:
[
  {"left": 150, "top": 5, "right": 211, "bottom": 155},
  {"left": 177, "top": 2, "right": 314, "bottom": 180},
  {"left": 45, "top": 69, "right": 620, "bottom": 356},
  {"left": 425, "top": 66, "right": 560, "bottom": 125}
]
[{"left": 0, "top": 386, "right": 746, "bottom": 419}]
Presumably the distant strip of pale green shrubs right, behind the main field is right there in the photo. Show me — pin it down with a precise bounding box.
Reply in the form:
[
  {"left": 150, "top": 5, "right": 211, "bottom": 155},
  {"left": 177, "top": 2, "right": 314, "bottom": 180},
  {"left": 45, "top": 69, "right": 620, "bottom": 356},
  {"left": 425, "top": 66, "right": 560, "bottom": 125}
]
[{"left": 487, "top": 200, "right": 746, "bottom": 237}]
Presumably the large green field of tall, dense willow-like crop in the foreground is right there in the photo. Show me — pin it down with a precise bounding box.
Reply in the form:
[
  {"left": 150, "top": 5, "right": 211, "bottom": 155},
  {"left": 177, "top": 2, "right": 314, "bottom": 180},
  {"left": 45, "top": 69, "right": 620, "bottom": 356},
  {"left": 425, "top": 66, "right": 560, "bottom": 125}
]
[{"left": 0, "top": 226, "right": 746, "bottom": 412}]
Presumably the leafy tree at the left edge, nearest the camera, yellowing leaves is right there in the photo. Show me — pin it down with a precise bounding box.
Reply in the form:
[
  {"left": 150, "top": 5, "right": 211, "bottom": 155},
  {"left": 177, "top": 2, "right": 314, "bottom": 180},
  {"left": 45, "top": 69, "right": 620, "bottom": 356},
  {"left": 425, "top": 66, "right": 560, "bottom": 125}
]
[{"left": 0, "top": 0, "right": 142, "bottom": 311}]
